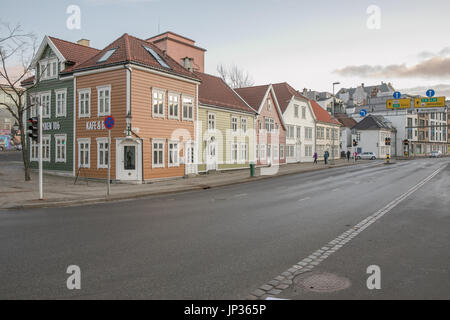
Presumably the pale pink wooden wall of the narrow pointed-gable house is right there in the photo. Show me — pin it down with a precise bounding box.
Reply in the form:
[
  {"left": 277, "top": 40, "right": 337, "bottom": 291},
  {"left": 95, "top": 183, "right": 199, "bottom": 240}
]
[{"left": 256, "top": 92, "right": 286, "bottom": 165}]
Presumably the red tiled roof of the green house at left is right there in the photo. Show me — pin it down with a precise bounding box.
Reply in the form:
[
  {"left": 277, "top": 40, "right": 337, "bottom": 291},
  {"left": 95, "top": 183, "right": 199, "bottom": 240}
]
[{"left": 49, "top": 37, "right": 100, "bottom": 73}]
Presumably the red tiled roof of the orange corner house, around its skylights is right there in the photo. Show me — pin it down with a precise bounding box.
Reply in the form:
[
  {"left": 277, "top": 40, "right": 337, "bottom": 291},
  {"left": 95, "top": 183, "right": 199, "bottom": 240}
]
[{"left": 76, "top": 33, "right": 198, "bottom": 80}]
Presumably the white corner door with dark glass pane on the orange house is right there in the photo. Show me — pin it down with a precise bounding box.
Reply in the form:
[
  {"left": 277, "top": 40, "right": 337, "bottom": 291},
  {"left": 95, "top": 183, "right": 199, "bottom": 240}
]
[{"left": 118, "top": 142, "right": 139, "bottom": 181}]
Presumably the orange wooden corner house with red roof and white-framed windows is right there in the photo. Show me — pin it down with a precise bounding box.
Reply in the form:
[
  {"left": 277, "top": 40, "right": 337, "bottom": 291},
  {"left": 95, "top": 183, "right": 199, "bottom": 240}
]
[{"left": 74, "top": 34, "right": 200, "bottom": 183}]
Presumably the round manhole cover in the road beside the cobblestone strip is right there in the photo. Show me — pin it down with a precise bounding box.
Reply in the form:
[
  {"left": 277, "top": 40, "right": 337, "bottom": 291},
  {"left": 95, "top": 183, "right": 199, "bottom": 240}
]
[{"left": 294, "top": 273, "right": 351, "bottom": 292}]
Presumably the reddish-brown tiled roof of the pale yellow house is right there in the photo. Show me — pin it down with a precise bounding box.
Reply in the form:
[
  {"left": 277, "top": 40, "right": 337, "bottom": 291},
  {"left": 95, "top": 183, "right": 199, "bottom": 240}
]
[{"left": 194, "top": 72, "right": 256, "bottom": 113}]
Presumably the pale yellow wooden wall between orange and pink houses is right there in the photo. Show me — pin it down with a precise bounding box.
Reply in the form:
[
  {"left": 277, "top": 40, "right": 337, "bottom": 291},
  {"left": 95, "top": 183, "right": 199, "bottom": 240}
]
[{"left": 198, "top": 105, "right": 255, "bottom": 172}]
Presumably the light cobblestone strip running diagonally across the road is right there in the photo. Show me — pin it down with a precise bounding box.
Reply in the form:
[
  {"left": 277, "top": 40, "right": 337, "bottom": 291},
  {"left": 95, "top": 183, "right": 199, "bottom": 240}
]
[{"left": 247, "top": 164, "right": 448, "bottom": 300}]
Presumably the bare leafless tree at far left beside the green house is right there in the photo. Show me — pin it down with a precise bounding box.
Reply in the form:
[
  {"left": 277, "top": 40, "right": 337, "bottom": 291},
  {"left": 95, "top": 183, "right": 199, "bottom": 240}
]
[{"left": 0, "top": 23, "right": 36, "bottom": 181}]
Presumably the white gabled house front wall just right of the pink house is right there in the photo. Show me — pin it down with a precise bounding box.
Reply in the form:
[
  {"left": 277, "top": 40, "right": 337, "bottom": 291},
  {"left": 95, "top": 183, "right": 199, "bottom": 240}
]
[{"left": 283, "top": 99, "right": 316, "bottom": 163}]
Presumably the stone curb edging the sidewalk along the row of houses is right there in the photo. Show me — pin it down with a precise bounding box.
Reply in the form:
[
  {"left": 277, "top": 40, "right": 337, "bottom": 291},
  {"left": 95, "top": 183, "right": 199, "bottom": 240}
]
[{"left": 4, "top": 163, "right": 372, "bottom": 210}]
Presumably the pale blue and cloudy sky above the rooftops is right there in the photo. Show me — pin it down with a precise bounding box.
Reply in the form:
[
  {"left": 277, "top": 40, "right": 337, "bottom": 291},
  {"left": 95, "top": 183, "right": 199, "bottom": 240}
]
[{"left": 0, "top": 0, "right": 450, "bottom": 95}]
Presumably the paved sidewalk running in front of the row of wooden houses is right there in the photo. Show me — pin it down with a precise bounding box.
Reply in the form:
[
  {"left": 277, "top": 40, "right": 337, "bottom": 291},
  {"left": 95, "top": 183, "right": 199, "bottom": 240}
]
[{"left": 0, "top": 159, "right": 367, "bottom": 209}]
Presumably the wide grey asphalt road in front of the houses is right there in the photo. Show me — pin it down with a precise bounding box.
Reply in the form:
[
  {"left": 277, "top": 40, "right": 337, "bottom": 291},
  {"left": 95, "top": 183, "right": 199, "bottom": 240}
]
[{"left": 0, "top": 158, "right": 450, "bottom": 299}]
